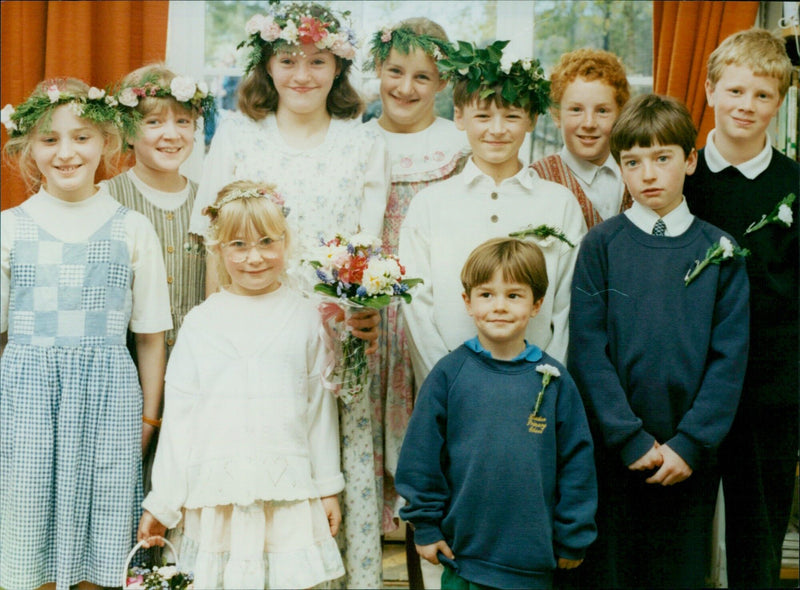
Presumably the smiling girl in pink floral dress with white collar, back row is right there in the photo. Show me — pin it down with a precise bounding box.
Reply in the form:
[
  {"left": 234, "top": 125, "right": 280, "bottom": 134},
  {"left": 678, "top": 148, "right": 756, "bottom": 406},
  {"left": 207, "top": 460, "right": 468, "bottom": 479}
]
[{"left": 366, "top": 18, "right": 470, "bottom": 568}]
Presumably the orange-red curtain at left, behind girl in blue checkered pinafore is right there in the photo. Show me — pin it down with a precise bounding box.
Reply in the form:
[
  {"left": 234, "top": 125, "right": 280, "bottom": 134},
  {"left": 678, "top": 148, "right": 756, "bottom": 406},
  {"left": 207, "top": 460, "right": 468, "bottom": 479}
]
[{"left": 0, "top": 0, "right": 169, "bottom": 209}]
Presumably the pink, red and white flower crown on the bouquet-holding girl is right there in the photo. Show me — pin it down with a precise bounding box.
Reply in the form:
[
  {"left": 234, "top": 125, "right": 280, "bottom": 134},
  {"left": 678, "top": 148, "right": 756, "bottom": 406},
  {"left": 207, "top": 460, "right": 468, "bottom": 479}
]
[{"left": 236, "top": 2, "right": 357, "bottom": 75}]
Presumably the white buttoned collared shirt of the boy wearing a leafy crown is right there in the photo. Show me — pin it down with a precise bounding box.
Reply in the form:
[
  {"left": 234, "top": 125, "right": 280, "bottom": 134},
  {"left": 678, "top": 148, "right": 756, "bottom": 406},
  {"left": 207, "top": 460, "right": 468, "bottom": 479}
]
[{"left": 399, "top": 158, "right": 586, "bottom": 383}]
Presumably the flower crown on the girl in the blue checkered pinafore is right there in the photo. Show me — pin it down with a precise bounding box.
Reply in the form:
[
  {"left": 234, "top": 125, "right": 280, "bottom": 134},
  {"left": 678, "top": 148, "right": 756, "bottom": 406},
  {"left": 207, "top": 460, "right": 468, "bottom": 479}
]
[{"left": 0, "top": 80, "right": 141, "bottom": 137}]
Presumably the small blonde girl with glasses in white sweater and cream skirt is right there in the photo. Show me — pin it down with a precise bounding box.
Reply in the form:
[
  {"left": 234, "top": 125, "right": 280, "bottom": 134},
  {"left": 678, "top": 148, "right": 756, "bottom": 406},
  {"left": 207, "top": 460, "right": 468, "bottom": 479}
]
[{"left": 139, "top": 181, "right": 344, "bottom": 588}]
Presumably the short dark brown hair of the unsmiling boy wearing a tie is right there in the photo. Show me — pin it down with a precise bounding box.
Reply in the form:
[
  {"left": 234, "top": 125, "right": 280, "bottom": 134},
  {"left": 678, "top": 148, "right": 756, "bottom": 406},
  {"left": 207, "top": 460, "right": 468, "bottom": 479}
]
[{"left": 610, "top": 94, "right": 697, "bottom": 162}]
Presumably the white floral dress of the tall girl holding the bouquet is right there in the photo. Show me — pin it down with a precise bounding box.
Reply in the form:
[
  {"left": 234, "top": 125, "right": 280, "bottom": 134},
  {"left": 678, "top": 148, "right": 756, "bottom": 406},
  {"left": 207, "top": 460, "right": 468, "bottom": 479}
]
[{"left": 189, "top": 113, "right": 389, "bottom": 588}]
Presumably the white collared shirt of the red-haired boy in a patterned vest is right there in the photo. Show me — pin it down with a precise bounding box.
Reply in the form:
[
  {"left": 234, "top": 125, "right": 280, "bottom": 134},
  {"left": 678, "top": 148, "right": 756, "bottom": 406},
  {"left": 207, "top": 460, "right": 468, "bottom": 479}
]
[{"left": 559, "top": 146, "right": 625, "bottom": 219}]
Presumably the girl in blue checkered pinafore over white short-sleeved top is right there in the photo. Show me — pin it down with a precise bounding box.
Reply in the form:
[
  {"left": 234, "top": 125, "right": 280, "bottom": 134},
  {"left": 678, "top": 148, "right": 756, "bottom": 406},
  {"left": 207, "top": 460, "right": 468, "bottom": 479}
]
[{"left": 0, "top": 79, "right": 172, "bottom": 590}]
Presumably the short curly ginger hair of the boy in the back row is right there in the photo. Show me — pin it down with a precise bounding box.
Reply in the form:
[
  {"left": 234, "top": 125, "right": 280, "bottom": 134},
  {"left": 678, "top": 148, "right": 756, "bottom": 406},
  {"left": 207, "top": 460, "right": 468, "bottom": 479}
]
[{"left": 550, "top": 48, "right": 631, "bottom": 109}]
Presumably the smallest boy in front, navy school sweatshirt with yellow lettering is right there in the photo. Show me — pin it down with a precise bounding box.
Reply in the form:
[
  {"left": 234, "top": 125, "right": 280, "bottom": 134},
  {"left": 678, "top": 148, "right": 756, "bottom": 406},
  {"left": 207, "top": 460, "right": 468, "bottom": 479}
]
[{"left": 396, "top": 238, "right": 597, "bottom": 588}]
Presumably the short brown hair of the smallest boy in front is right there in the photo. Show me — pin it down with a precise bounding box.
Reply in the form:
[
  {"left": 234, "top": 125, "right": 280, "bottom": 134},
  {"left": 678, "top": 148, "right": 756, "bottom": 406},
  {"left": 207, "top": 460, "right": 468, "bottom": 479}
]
[{"left": 461, "top": 238, "right": 548, "bottom": 301}]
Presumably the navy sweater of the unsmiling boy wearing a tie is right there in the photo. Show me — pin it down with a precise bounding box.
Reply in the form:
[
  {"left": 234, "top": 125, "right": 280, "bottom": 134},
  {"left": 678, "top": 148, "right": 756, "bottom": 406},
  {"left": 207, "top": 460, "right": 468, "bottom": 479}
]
[{"left": 568, "top": 214, "right": 749, "bottom": 469}]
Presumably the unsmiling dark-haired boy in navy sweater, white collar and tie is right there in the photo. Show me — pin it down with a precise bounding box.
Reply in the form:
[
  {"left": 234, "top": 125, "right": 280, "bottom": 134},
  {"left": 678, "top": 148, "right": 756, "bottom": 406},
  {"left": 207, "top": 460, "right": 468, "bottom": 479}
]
[{"left": 568, "top": 95, "right": 749, "bottom": 588}]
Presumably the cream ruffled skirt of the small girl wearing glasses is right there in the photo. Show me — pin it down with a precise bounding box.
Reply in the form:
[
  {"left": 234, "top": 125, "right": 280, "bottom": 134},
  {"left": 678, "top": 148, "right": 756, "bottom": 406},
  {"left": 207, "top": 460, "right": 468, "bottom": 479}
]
[{"left": 168, "top": 498, "right": 345, "bottom": 590}]
